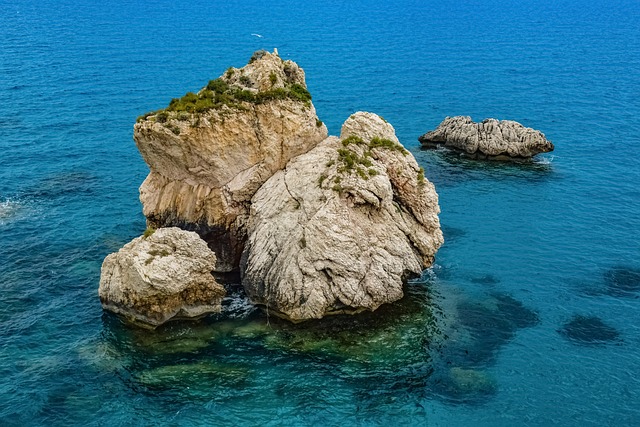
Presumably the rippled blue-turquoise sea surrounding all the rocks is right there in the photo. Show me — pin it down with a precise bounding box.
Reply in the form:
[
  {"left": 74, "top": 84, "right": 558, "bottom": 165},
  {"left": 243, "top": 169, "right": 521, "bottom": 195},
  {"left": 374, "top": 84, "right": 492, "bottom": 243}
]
[{"left": 0, "top": 0, "right": 640, "bottom": 426}]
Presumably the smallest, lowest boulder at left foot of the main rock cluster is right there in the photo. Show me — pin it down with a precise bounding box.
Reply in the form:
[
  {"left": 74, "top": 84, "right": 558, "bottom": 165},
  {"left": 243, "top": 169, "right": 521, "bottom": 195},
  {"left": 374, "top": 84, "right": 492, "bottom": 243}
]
[{"left": 98, "top": 227, "right": 225, "bottom": 328}]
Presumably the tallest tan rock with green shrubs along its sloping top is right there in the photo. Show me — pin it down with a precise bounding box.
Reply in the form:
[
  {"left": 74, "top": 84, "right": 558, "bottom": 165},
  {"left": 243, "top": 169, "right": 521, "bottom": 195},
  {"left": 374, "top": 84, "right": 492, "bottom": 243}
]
[{"left": 134, "top": 52, "right": 327, "bottom": 271}]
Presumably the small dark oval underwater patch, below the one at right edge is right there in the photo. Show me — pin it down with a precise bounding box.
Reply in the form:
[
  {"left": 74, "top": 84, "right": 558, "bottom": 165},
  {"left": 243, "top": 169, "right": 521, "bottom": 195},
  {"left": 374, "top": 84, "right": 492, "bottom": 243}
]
[{"left": 558, "top": 315, "right": 622, "bottom": 346}]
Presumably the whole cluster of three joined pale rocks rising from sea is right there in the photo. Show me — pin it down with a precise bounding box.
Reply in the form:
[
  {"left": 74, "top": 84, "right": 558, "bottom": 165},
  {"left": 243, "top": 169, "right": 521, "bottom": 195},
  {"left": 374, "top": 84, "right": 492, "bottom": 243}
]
[{"left": 99, "top": 51, "right": 443, "bottom": 326}]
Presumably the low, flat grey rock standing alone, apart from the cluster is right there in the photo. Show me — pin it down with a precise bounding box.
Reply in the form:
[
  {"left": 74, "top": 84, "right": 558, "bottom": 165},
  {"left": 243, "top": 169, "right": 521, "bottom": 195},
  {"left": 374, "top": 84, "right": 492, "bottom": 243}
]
[{"left": 418, "top": 116, "right": 554, "bottom": 160}]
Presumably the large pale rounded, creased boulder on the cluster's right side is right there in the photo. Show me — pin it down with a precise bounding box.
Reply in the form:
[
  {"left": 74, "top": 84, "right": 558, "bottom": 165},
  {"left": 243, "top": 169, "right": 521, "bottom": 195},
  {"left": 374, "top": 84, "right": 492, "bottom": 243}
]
[{"left": 242, "top": 113, "right": 443, "bottom": 321}]
